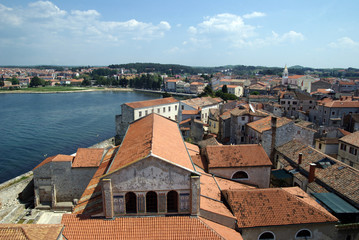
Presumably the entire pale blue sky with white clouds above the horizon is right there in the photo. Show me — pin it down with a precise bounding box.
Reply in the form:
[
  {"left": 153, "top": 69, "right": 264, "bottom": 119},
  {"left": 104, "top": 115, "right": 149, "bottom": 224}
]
[{"left": 0, "top": 0, "right": 359, "bottom": 68}]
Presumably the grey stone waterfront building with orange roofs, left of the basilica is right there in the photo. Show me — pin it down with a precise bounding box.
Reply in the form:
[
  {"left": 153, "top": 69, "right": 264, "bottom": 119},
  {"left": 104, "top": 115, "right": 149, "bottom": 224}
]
[{"left": 33, "top": 148, "right": 104, "bottom": 210}]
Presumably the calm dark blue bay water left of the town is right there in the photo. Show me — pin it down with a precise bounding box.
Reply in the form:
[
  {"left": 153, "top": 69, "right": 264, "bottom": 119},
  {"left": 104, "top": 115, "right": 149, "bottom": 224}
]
[{"left": 0, "top": 92, "right": 160, "bottom": 183}]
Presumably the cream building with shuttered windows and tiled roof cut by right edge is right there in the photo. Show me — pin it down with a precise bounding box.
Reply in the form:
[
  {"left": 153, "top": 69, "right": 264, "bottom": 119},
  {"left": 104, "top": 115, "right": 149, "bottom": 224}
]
[{"left": 338, "top": 131, "right": 359, "bottom": 169}]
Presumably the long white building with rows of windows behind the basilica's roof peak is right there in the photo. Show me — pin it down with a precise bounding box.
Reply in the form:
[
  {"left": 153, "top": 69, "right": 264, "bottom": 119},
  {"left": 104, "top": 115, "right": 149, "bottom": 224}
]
[{"left": 115, "top": 97, "right": 179, "bottom": 145}]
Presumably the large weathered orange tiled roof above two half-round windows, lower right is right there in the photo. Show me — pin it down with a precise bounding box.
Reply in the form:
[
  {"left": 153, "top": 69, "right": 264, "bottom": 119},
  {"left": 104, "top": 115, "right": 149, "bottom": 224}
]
[{"left": 223, "top": 188, "right": 338, "bottom": 228}]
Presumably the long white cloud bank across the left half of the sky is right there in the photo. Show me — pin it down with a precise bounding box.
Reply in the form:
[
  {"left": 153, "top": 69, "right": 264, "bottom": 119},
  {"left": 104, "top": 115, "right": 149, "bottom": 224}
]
[{"left": 0, "top": 1, "right": 171, "bottom": 44}]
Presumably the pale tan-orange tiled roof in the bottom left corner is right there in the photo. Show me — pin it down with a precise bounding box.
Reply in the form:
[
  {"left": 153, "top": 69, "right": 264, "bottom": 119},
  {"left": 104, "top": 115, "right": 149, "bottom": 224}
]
[{"left": 0, "top": 224, "right": 63, "bottom": 240}]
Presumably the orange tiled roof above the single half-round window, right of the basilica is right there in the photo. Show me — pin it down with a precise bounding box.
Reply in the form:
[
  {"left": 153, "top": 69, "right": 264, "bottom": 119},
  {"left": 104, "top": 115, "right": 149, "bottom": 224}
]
[{"left": 206, "top": 144, "right": 272, "bottom": 168}]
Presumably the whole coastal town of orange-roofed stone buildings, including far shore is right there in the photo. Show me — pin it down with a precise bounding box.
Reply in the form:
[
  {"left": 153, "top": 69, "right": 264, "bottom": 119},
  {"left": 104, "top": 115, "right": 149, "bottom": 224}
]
[{"left": 0, "top": 65, "right": 359, "bottom": 240}]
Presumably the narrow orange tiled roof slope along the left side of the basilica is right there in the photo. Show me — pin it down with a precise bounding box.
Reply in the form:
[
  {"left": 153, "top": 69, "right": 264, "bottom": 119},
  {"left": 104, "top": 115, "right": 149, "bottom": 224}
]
[{"left": 73, "top": 147, "right": 119, "bottom": 215}]
